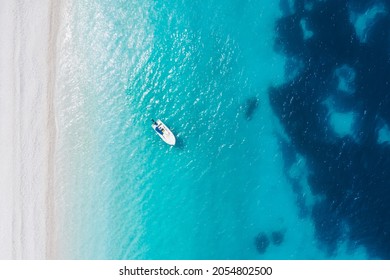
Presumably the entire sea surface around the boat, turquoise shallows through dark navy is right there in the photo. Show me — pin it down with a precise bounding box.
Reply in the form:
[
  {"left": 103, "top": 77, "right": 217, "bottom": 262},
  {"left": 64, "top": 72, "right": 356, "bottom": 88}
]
[{"left": 56, "top": 0, "right": 390, "bottom": 259}]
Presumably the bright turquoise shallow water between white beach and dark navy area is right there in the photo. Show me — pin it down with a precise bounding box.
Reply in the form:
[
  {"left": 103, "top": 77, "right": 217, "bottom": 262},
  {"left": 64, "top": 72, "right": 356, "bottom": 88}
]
[{"left": 56, "top": 0, "right": 364, "bottom": 259}]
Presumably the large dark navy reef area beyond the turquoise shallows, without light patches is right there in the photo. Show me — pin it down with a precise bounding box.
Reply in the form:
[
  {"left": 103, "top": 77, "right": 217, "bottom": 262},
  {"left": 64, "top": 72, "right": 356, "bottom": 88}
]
[{"left": 272, "top": 0, "right": 390, "bottom": 259}]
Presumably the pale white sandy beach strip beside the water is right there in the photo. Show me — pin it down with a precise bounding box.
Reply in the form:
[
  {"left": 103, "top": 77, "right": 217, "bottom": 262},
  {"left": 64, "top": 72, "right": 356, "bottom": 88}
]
[{"left": 0, "top": 0, "right": 60, "bottom": 259}]
